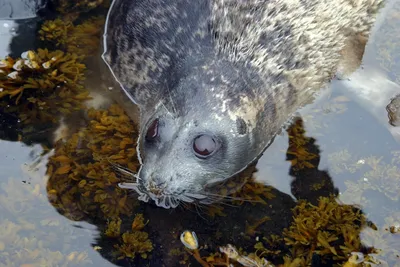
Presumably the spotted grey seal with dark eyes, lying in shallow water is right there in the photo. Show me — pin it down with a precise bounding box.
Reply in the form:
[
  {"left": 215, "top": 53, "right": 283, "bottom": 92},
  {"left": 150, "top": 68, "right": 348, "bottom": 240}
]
[{"left": 102, "top": 0, "right": 383, "bottom": 208}]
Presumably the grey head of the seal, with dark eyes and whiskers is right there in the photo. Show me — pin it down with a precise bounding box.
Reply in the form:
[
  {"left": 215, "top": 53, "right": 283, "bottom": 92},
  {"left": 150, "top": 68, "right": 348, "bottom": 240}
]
[{"left": 126, "top": 58, "right": 274, "bottom": 207}]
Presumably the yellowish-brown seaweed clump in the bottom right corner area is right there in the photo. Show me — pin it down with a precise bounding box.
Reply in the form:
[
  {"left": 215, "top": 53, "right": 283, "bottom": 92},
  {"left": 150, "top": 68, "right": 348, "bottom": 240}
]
[{"left": 283, "top": 197, "right": 373, "bottom": 264}]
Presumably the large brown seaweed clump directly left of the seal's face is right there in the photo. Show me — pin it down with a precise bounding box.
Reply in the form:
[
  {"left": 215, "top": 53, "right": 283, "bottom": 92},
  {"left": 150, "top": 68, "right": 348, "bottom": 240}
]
[{"left": 47, "top": 104, "right": 139, "bottom": 220}]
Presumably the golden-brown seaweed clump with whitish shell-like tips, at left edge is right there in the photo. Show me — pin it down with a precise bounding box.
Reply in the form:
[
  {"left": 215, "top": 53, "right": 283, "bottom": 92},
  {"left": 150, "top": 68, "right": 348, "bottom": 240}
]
[{"left": 0, "top": 49, "right": 89, "bottom": 124}]
